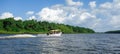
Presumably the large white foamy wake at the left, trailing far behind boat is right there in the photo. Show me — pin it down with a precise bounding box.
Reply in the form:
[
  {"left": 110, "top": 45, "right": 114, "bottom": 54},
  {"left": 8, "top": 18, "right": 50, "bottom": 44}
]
[{"left": 0, "top": 34, "right": 36, "bottom": 39}]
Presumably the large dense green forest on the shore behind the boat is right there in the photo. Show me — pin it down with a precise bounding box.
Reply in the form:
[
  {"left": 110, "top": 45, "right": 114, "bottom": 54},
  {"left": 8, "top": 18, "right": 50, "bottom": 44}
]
[{"left": 0, "top": 18, "right": 94, "bottom": 34}]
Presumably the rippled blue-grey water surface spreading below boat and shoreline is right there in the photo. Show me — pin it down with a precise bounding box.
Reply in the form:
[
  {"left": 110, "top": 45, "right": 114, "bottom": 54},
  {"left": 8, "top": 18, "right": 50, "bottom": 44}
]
[{"left": 0, "top": 34, "right": 120, "bottom": 54}]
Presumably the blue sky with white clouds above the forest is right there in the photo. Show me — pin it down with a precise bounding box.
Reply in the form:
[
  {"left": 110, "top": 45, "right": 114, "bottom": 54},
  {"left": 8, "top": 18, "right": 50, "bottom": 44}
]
[{"left": 0, "top": 0, "right": 120, "bottom": 32}]
